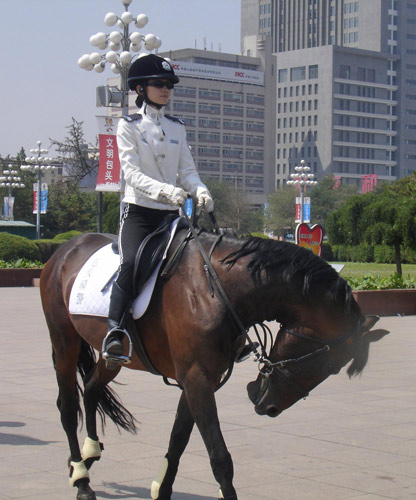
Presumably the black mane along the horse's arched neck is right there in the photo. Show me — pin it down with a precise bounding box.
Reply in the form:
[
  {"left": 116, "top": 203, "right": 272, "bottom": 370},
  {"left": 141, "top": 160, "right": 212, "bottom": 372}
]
[{"left": 222, "top": 237, "right": 356, "bottom": 314}]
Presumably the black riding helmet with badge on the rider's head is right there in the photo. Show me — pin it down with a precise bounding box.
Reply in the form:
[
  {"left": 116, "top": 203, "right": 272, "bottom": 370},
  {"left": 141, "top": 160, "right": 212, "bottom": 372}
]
[{"left": 127, "top": 54, "right": 179, "bottom": 90}]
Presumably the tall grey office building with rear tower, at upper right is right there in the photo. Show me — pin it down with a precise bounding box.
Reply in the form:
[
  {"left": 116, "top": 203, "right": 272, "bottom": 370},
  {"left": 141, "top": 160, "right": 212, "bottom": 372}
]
[{"left": 241, "top": 0, "right": 416, "bottom": 187}]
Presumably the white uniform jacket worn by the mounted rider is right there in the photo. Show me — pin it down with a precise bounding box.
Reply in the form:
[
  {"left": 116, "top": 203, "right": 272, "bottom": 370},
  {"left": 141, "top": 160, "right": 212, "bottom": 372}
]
[{"left": 117, "top": 104, "right": 206, "bottom": 210}]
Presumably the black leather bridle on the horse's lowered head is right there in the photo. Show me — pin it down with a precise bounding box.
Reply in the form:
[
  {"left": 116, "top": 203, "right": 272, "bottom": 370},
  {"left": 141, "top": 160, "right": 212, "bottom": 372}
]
[{"left": 253, "top": 324, "right": 354, "bottom": 406}]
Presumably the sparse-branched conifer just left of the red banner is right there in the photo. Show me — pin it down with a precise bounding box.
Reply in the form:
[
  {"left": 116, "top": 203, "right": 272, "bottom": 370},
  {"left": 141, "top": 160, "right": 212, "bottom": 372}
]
[{"left": 50, "top": 118, "right": 97, "bottom": 185}]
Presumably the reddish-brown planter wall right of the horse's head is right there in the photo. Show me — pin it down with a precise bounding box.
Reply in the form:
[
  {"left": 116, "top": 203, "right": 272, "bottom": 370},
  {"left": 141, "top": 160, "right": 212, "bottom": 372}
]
[{"left": 353, "top": 289, "right": 416, "bottom": 316}]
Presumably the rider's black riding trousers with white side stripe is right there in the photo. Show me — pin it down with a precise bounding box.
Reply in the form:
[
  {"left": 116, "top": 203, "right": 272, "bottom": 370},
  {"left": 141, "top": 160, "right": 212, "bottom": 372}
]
[{"left": 116, "top": 203, "right": 176, "bottom": 295}]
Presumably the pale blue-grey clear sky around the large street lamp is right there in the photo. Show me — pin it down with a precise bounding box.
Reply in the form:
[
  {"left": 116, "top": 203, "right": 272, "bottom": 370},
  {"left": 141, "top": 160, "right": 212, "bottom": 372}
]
[{"left": 0, "top": 0, "right": 241, "bottom": 157}]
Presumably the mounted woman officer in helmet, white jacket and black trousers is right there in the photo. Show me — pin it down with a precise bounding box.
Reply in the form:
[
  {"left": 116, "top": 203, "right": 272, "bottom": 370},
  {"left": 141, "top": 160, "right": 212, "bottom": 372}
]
[{"left": 103, "top": 54, "right": 214, "bottom": 362}]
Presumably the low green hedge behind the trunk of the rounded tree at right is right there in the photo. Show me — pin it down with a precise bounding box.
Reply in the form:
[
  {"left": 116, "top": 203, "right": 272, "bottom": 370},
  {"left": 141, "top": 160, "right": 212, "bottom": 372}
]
[{"left": 322, "top": 243, "right": 416, "bottom": 264}]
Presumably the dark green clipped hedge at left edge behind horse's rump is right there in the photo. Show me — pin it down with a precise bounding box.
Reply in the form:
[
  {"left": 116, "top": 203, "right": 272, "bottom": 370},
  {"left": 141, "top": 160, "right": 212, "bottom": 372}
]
[{"left": 0, "top": 231, "right": 81, "bottom": 263}]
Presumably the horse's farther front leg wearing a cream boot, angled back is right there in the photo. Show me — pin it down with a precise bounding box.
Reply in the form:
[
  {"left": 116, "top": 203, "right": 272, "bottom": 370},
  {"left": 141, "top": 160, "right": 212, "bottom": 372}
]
[{"left": 151, "top": 392, "right": 194, "bottom": 500}]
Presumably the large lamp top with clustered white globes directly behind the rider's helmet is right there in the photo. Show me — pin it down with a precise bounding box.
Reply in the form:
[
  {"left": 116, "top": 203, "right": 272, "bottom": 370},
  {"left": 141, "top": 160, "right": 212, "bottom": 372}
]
[{"left": 78, "top": 0, "right": 162, "bottom": 115}]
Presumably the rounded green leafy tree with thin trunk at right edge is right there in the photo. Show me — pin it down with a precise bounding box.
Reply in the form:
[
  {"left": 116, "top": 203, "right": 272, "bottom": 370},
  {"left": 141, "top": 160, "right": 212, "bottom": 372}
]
[{"left": 327, "top": 188, "right": 416, "bottom": 276}]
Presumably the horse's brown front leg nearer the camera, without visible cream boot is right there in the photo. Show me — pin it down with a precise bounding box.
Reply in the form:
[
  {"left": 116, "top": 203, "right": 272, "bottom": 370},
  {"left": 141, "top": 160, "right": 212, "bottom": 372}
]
[{"left": 184, "top": 369, "right": 237, "bottom": 500}]
